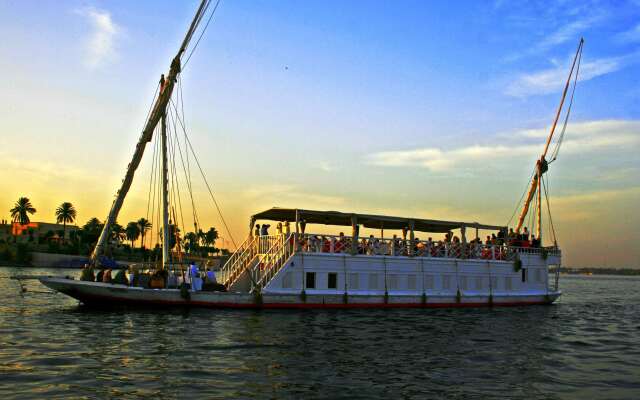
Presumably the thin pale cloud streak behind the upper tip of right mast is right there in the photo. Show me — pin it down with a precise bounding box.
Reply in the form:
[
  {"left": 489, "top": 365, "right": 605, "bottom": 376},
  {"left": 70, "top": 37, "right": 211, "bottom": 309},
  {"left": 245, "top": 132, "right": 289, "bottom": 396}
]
[{"left": 504, "top": 53, "right": 624, "bottom": 97}]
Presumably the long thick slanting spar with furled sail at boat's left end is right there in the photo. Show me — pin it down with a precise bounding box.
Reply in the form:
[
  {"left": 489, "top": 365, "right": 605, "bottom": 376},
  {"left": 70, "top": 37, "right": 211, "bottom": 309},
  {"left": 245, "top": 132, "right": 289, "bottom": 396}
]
[{"left": 91, "top": 0, "right": 210, "bottom": 264}]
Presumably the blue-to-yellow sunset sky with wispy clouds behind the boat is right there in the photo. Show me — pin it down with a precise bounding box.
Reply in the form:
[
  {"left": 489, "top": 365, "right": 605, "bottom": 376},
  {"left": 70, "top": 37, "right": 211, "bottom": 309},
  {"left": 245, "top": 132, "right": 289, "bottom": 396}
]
[{"left": 0, "top": 0, "right": 640, "bottom": 267}]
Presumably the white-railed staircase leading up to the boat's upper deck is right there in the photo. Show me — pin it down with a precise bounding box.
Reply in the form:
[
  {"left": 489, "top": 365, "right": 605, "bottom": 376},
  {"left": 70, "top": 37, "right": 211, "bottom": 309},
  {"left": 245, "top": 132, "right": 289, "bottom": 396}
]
[{"left": 219, "top": 234, "right": 294, "bottom": 292}]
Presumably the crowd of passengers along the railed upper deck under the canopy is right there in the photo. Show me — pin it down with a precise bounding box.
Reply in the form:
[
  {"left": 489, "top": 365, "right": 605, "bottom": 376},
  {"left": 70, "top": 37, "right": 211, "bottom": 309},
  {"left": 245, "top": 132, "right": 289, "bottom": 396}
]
[{"left": 254, "top": 220, "right": 541, "bottom": 259}]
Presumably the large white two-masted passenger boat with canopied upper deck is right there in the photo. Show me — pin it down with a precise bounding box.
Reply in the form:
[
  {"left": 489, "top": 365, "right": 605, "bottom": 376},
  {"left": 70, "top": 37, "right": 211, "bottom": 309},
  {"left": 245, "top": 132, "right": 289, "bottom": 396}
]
[{"left": 40, "top": 0, "right": 584, "bottom": 309}]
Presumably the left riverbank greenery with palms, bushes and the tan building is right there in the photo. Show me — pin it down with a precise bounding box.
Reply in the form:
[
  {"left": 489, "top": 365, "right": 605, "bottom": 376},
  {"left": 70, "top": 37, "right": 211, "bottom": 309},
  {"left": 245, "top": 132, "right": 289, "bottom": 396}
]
[{"left": 0, "top": 197, "right": 229, "bottom": 266}]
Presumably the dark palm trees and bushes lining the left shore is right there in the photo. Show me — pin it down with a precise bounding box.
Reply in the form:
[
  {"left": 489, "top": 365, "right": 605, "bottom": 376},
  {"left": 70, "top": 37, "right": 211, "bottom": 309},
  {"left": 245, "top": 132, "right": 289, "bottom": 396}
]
[{"left": 0, "top": 197, "right": 227, "bottom": 261}]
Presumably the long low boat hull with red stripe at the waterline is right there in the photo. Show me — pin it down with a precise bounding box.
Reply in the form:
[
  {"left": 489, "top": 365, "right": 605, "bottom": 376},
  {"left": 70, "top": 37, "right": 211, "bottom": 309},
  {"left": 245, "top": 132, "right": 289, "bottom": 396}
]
[{"left": 40, "top": 277, "right": 561, "bottom": 309}]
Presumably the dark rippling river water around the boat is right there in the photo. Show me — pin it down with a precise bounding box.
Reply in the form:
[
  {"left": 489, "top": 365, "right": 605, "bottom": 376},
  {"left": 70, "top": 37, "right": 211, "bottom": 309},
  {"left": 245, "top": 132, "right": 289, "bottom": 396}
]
[{"left": 0, "top": 268, "right": 640, "bottom": 399}]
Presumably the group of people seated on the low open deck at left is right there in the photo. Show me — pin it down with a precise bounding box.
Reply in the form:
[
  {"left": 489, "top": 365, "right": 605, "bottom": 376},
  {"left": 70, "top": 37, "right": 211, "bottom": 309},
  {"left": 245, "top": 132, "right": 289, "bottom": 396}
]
[{"left": 80, "top": 263, "right": 226, "bottom": 291}]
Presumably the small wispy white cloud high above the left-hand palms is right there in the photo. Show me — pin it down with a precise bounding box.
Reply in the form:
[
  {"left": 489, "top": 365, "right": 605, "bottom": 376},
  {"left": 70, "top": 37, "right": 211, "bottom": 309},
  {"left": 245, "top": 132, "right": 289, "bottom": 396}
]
[{"left": 76, "top": 7, "right": 122, "bottom": 69}]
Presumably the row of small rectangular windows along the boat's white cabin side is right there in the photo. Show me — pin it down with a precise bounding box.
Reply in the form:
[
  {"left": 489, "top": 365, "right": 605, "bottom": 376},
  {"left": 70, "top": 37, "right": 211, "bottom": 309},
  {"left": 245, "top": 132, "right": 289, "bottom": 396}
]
[{"left": 296, "top": 268, "right": 544, "bottom": 290}]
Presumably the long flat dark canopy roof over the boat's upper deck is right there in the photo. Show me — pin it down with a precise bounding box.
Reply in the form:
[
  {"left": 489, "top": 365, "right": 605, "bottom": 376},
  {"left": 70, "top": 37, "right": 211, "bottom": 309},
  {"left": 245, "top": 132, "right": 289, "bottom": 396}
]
[{"left": 251, "top": 207, "right": 504, "bottom": 233}]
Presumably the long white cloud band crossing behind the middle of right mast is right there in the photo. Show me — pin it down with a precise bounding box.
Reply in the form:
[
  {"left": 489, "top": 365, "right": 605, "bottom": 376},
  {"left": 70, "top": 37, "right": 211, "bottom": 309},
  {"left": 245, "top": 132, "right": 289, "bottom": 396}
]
[{"left": 366, "top": 120, "right": 640, "bottom": 172}]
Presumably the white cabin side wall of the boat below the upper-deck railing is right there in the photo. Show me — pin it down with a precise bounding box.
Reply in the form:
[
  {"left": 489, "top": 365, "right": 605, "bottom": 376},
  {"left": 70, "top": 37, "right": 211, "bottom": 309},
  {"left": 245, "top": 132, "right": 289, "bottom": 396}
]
[{"left": 263, "top": 253, "right": 550, "bottom": 296}]
